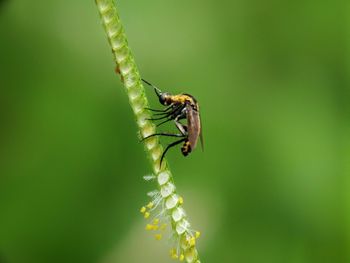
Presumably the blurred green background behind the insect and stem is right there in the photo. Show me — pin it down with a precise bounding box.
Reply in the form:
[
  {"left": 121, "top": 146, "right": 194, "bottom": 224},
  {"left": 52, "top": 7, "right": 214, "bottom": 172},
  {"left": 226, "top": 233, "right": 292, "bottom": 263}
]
[{"left": 0, "top": 0, "right": 350, "bottom": 263}]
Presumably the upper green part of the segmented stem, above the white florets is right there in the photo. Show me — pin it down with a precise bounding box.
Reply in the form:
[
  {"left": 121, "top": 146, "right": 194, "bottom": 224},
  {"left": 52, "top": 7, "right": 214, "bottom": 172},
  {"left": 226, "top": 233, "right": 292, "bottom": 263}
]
[{"left": 96, "top": 0, "right": 166, "bottom": 174}]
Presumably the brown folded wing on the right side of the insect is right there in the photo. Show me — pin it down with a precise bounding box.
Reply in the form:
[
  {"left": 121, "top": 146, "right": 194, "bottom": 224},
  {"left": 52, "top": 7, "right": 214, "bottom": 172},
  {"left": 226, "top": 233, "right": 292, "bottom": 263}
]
[{"left": 186, "top": 103, "right": 201, "bottom": 150}]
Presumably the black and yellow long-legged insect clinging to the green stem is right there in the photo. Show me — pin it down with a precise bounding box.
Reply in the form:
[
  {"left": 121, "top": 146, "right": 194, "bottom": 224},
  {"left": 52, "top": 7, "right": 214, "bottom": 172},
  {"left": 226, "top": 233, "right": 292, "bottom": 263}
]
[{"left": 142, "top": 79, "right": 203, "bottom": 166}]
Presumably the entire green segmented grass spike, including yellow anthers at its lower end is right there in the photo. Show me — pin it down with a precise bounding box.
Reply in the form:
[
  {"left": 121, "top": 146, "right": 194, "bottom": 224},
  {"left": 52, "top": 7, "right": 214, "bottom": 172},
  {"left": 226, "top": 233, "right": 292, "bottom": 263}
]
[{"left": 96, "top": 0, "right": 199, "bottom": 262}]
